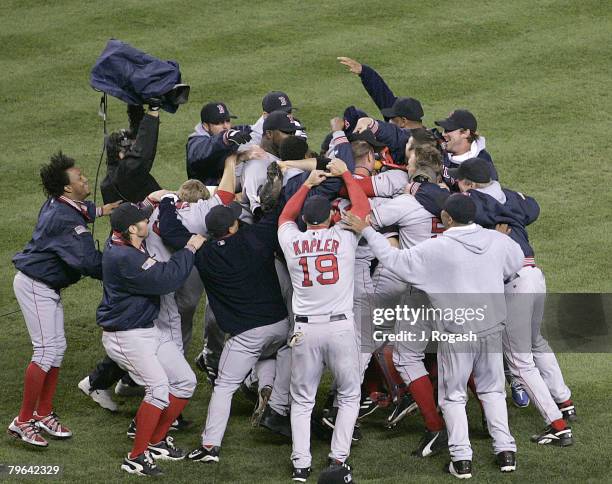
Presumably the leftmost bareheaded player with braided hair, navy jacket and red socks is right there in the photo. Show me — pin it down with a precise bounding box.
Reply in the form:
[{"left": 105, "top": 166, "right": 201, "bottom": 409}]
[{"left": 8, "top": 151, "right": 118, "bottom": 447}]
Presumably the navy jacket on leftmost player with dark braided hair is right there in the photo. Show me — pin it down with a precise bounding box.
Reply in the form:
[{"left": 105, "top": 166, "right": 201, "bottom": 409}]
[{"left": 13, "top": 198, "right": 102, "bottom": 289}]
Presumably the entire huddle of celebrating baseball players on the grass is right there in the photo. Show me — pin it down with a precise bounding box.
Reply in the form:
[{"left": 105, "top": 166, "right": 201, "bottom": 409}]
[{"left": 8, "top": 57, "right": 577, "bottom": 483}]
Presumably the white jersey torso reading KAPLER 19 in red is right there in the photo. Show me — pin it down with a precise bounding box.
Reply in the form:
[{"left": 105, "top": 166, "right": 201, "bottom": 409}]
[{"left": 278, "top": 222, "right": 358, "bottom": 317}]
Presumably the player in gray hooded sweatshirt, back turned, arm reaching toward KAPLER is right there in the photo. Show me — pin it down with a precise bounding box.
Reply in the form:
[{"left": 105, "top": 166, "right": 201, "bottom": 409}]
[{"left": 344, "top": 194, "right": 523, "bottom": 479}]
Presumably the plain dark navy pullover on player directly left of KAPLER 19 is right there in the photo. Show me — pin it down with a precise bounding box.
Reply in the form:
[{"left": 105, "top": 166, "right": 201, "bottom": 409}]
[{"left": 159, "top": 201, "right": 287, "bottom": 335}]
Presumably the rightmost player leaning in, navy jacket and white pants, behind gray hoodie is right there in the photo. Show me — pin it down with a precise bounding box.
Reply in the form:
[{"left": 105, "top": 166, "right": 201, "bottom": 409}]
[{"left": 415, "top": 158, "right": 577, "bottom": 446}]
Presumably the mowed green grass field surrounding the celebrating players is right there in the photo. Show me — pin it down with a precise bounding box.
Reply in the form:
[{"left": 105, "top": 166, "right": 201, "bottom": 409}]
[{"left": 0, "top": 0, "right": 612, "bottom": 482}]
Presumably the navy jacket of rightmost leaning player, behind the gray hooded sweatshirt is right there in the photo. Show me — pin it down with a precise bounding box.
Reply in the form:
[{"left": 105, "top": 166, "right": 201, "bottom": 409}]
[{"left": 415, "top": 183, "right": 540, "bottom": 257}]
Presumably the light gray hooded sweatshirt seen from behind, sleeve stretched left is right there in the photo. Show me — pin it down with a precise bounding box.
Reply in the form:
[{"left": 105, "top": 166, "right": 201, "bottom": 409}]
[{"left": 363, "top": 224, "right": 523, "bottom": 335}]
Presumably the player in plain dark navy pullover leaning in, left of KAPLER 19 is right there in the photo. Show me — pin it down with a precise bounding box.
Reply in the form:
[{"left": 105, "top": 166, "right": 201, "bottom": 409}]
[{"left": 160, "top": 188, "right": 289, "bottom": 462}]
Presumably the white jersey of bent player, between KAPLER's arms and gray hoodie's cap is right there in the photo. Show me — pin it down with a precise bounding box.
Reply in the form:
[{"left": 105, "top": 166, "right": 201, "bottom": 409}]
[{"left": 371, "top": 194, "right": 444, "bottom": 249}]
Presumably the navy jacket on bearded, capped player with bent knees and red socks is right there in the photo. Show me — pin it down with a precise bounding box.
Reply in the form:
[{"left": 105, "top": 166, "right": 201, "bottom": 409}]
[{"left": 96, "top": 235, "right": 195, "bottom": 331}]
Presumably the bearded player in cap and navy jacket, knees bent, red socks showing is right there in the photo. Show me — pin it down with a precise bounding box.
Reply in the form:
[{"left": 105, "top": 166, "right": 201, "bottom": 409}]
[{"left": 96, "top": 203, "right": 204, "bottom": 476}]
